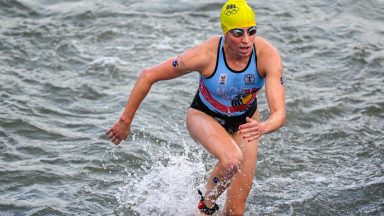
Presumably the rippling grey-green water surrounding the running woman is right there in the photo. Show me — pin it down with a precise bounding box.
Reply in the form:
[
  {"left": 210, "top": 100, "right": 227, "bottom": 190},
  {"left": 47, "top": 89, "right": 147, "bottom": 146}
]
[{"left": 0, "top": 0, "right": 384, "bottom": 215}]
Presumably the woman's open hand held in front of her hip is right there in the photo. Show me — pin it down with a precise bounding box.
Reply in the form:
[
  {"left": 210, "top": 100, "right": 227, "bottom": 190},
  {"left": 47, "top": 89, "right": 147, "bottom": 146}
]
[{"left": 238, "top": 117, "right": 265, "bottom": 142}]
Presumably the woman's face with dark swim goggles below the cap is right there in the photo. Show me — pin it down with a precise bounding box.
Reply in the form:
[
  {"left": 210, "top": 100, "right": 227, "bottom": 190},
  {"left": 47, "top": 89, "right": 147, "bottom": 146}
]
[{"left": 225, "top": 26, "right": 257, "bottom": 56}]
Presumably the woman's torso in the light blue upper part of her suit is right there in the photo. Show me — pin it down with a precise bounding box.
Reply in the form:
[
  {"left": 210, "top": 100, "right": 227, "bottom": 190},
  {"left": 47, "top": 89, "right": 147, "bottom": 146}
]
[{"left": 199, "top": 37, "right": 265, "bottom": 116}]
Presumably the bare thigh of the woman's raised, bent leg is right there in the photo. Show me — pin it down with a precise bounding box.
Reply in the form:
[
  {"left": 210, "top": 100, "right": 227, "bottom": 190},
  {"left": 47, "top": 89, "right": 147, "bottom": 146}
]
[{"left": 187, "top": 108, "right": 241, "bottom": 160}]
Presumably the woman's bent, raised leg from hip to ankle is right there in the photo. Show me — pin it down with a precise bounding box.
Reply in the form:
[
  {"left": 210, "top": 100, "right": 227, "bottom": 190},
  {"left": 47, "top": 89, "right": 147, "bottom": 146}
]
[{"left": 187, "top": 108, "right": 243, "bottom": 208}]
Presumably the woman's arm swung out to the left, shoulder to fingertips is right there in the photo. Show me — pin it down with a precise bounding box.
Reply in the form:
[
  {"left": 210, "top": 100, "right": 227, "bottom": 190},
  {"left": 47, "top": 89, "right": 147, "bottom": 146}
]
[{"left": 107, "top": 36, "right": 218, "bottom": 145}]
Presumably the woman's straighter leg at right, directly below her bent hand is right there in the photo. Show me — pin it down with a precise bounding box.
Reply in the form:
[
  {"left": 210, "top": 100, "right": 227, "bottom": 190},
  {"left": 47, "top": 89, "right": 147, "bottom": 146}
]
[{"left": 223, "top": 134, "right": 259, "bottom": 216}]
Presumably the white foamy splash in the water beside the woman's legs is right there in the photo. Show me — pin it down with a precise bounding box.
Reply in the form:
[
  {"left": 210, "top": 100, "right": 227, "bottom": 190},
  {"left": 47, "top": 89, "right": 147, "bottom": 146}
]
[{"left": 117, "top": 144, "right": 206, "bottom": 215}]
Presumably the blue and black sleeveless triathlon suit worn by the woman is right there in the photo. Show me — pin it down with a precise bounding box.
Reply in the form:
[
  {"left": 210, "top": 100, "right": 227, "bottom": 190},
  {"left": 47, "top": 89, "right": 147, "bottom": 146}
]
[{"left": 191, "top": 36, "right": 265, "bottom": 133}]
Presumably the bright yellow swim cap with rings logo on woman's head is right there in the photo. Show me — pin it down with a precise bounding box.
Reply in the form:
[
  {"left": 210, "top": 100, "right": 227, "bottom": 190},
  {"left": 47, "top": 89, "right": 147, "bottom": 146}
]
[{"left": 220, "top": 0, "right": 256, "bottom": 34}]
